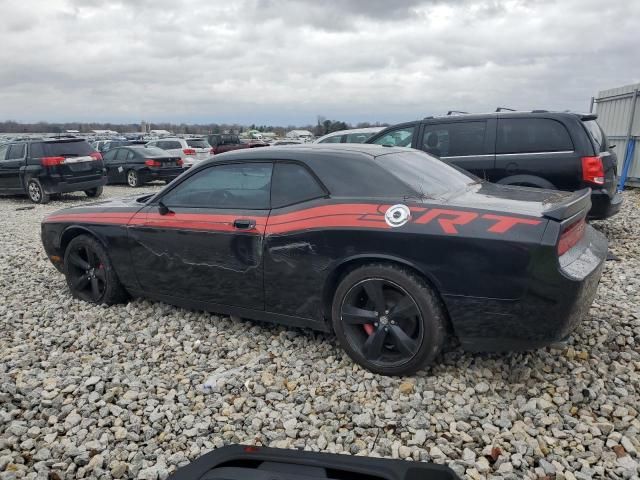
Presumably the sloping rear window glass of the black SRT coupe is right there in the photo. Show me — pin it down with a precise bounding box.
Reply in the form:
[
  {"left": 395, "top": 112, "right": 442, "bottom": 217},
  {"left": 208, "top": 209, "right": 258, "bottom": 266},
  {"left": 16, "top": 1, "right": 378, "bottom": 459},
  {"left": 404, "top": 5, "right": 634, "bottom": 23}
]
[{"left": 376, "top": 151, "right": 478, "bottom": 198}]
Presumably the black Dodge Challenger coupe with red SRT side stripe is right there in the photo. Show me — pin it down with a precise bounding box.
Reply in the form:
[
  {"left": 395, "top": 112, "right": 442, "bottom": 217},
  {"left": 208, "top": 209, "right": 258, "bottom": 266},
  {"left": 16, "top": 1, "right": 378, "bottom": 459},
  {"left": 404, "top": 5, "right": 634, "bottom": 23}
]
[{"left": 42, "top": 144, "right": 607, "bottom": 375}]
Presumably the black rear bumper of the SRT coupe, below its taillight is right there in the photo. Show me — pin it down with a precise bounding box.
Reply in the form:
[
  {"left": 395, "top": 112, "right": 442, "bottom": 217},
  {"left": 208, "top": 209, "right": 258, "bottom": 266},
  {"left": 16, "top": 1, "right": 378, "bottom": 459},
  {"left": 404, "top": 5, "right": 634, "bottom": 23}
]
[{"left": 444, "top": 227, "right": 607, "bottom": 351}]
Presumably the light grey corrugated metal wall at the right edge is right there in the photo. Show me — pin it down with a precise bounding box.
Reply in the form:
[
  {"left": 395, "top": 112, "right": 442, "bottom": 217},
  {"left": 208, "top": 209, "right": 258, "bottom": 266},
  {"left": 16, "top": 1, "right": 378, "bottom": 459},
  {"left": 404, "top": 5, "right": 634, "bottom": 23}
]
[{"left": 591, "top": 83, "right": 640, "bottom": 187}]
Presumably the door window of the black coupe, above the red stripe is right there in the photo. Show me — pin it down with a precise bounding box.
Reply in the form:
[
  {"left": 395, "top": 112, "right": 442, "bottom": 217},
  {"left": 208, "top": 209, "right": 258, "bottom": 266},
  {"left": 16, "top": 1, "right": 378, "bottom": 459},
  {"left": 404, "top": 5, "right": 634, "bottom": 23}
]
[{"left": 162, "top": 163, "right": 273, "bottom": 210}]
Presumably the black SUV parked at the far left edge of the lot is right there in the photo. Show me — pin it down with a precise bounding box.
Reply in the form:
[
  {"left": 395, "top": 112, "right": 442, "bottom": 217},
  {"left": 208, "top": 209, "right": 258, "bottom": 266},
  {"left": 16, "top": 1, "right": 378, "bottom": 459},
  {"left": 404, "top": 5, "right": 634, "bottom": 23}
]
[{"left": 0, "top": 137, "right": 107, "bottom": 203}]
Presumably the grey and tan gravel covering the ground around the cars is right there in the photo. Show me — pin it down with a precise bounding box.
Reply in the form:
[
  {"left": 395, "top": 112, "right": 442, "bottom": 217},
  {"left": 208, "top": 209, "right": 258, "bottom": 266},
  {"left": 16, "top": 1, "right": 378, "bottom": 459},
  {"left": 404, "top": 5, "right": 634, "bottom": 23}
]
[{"left": 0, "top": 187, "right": 640, "bottom": 479}]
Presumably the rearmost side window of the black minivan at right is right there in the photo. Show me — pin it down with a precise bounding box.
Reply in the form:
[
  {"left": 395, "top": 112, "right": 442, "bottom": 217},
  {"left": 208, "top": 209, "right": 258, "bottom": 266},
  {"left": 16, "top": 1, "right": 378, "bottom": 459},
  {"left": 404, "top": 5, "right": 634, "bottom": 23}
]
[{"left": 496, "top": 118, "right": 573, "bottom": 153}]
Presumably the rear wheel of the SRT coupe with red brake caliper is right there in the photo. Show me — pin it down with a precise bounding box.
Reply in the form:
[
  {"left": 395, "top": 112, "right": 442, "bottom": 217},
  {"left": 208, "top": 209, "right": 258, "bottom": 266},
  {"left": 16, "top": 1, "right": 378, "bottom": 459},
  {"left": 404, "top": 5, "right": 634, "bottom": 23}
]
[{"left": 331, "top": 264, "right": 446, "bottom": 375}]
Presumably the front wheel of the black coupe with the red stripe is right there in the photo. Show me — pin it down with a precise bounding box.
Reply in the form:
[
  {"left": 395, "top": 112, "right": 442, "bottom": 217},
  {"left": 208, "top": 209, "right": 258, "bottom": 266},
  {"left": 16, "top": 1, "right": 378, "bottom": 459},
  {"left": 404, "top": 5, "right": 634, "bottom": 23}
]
[{"left": 64, "top": 235, "right": 127, "bottom": 305}]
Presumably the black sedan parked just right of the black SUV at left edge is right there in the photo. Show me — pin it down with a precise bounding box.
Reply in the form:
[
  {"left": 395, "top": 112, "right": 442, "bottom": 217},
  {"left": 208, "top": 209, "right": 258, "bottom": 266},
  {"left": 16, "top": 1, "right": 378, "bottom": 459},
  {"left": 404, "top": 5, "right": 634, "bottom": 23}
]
[{"left": 104, "top": 145, "right": 183, "bottom": 187}]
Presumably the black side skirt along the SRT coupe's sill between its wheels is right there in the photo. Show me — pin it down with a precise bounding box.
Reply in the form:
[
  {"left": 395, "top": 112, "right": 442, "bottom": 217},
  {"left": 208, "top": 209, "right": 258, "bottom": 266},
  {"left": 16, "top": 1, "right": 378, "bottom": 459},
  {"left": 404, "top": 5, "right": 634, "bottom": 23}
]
[{"left": 128, "top": 289, "right": 331, "bottom": 332}]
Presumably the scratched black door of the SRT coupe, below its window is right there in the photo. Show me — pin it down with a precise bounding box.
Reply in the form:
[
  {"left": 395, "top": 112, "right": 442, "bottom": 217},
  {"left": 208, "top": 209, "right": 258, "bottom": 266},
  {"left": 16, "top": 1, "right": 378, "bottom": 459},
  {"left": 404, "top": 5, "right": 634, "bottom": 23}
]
[{"left": 129, "top": 207, "right": 268, "bottom": 309}]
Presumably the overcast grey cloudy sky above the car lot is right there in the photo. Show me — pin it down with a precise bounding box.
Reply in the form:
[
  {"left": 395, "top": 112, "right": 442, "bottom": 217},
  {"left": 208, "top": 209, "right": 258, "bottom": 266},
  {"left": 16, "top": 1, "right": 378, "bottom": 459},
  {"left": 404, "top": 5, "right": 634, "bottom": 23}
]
[{"left": 0, "top": 0, "right": 640, "bottom": 125}]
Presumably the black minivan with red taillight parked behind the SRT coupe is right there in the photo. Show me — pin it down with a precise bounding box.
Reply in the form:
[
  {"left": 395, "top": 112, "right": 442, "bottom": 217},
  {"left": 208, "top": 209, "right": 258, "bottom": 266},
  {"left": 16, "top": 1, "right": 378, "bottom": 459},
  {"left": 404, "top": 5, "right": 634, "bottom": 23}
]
[{"left": 365, "top": 110, "right": 622, "bottom": 219}]
